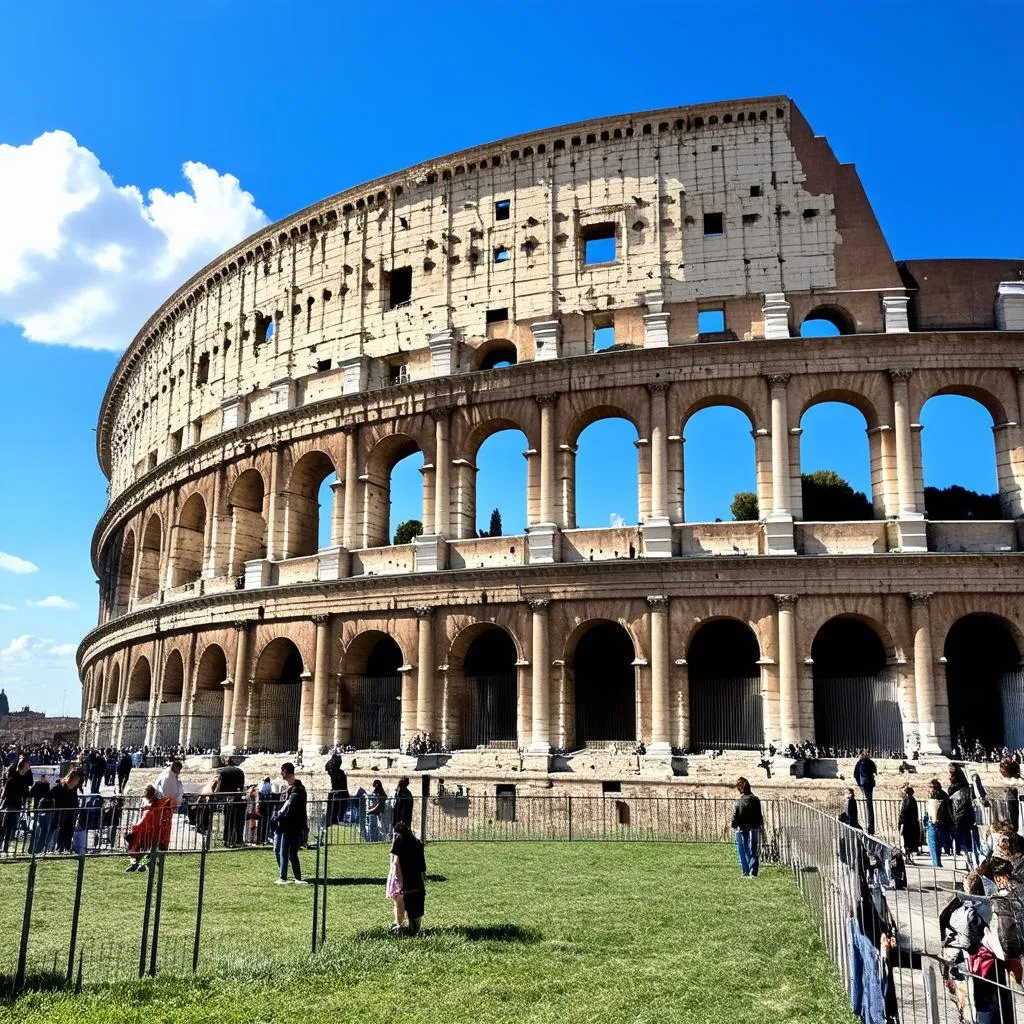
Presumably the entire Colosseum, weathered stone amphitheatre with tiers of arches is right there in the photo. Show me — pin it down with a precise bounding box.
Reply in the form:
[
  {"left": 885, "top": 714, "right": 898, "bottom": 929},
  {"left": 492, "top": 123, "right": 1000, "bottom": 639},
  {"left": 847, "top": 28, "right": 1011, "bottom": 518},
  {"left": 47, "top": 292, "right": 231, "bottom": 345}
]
[{"left": 78, "top": 97, "right": 1024, "bottom": 784}]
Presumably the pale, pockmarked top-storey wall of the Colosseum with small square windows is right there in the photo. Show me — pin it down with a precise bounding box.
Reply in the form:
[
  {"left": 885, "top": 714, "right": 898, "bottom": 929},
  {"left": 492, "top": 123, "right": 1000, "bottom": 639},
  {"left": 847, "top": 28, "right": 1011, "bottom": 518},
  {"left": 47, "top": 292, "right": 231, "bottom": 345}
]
[{"left": 97, "top": 97, "right": 903, "bottom": 496}]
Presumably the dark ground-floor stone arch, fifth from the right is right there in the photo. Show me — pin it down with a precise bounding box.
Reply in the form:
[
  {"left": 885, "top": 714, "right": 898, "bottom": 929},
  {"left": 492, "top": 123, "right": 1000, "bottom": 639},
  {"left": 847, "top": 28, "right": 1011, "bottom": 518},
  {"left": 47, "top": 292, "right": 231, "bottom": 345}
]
[{"left": 442, "top": 623, "right": 521, "bottom": 749}]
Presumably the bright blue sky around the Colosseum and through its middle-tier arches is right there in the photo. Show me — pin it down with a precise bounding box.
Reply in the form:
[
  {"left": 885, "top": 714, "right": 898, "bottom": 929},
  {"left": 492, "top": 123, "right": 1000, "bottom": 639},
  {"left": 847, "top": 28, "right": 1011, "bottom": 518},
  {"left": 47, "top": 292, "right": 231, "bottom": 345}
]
[{"left": 0, "top": 0, "right": 1024, "bottom": 713}]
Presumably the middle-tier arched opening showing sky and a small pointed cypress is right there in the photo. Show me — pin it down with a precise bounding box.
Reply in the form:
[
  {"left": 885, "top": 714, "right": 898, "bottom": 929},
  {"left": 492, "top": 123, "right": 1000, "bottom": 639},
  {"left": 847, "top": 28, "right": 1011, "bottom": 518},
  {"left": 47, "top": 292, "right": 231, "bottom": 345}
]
[{"left": 471, "top": 427, "right": 529, "bottom": 537}]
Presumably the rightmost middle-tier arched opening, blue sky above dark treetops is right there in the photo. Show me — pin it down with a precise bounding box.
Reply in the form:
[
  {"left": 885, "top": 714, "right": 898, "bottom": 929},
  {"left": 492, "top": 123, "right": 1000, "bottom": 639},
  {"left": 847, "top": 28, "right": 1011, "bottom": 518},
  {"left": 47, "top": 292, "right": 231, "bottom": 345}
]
[{"left": 921, "top": 394, "right": 1009, "bottom": 520}]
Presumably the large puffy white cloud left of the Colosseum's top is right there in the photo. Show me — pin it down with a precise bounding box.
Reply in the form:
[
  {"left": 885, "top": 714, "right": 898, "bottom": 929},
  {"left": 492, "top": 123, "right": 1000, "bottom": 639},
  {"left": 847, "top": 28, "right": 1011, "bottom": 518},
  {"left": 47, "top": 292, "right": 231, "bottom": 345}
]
[{"left": 0, "top": 131, "right": 267, "bottom": 349}]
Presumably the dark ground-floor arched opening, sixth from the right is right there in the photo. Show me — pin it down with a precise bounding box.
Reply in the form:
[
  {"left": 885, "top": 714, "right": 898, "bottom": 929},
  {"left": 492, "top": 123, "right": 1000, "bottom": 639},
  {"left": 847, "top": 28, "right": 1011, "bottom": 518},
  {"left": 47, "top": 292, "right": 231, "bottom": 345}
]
[{"left": 345, "top": 631, "right": 403, "bottom": 751}]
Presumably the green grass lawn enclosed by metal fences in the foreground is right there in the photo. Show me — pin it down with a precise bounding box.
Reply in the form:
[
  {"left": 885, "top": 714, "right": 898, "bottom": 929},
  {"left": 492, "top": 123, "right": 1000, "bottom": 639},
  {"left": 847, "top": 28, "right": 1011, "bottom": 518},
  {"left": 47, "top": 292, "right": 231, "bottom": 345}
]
[{"left": 0, "top": 843, "right": 855, "bottom": 1024}]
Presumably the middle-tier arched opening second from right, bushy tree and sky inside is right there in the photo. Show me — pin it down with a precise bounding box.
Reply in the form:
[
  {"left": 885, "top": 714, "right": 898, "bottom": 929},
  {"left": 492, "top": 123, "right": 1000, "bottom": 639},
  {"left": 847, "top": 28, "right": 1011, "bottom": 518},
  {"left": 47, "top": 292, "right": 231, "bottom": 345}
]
[{"left": 800, "top": 400, "right": 879, "bottom": 522}]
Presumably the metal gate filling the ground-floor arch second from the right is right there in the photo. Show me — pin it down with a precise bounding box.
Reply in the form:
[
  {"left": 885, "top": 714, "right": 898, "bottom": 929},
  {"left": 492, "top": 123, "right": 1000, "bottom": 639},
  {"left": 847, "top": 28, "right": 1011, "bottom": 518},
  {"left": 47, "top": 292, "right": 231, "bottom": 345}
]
[{"left": 814, "top": 672, "right": 906, "bottom": 756}]
